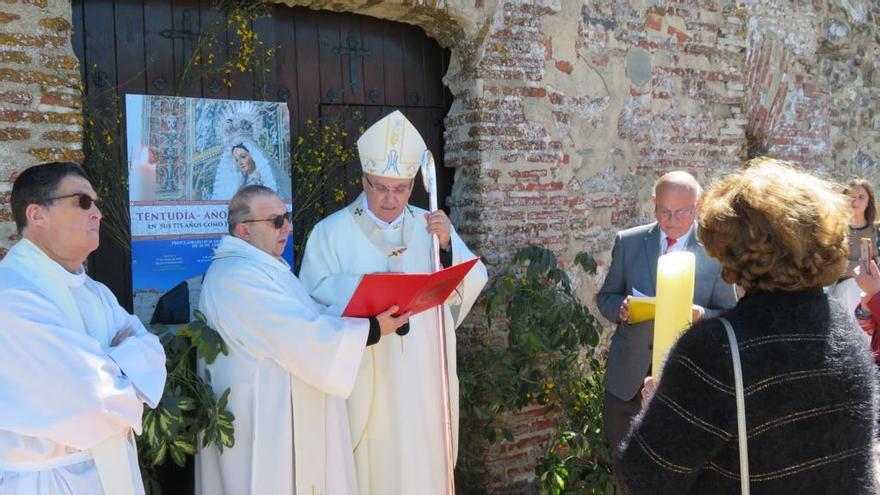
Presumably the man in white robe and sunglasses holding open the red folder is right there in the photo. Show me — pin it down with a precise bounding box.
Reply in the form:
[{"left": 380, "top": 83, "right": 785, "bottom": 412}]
[{"left": 196, "top": 185, "right": 409, "bottom": 495}]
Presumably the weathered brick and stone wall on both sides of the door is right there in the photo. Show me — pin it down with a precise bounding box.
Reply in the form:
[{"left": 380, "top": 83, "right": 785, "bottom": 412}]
[{"left": 0, "top": 0, "right": 880, "bottom": 494}]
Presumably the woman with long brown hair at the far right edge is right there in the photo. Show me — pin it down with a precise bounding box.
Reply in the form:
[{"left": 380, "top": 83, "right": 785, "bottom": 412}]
[{"left": 829, "top": 179, "right": 877, "bottom": 310}]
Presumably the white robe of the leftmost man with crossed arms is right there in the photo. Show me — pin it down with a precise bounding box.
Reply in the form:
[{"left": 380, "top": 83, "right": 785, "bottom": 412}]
[{"left": 0, "top": 239, "right": 165, "bottom": 495}]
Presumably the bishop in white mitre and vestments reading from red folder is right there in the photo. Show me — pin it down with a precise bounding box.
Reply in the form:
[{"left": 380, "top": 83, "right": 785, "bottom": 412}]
[{"left": 300, "top": 111, "right": 487, "bottom": 495}]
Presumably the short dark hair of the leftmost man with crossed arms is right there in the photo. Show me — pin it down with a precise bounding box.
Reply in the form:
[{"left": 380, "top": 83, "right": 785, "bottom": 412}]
[{"left": 11, "top": 162, "right": 89, "bottom": 234}]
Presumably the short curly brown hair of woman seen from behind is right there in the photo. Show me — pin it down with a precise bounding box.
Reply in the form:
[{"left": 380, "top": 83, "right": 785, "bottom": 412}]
[{"left": 698, "top": 157, "right": 851, "bottom": 292}]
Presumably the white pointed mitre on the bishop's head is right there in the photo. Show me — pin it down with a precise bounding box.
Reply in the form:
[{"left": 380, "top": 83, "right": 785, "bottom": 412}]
[{"left": 358, "top": 110, "right": 428, "bottom": 179}]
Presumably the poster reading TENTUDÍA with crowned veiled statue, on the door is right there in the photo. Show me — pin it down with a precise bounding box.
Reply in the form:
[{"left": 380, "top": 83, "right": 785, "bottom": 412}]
[{"left": 125, "top": 95, "right": 293, "bottom": 324}]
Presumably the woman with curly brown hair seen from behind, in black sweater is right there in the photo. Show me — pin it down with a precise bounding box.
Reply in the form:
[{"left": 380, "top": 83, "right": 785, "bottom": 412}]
[{"left": 615, "top": 158, "right": 880, "bottom": 495}]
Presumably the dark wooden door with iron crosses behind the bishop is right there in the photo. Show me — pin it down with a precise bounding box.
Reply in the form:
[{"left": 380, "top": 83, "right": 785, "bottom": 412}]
[{"left": 73, "top": 0, "right": 453, "bottom": 310}]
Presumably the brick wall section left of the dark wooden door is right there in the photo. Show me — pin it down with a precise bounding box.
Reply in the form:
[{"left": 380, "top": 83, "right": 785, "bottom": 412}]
[{"left": 0, "top": 0, "right": 82, "bottom": 257}]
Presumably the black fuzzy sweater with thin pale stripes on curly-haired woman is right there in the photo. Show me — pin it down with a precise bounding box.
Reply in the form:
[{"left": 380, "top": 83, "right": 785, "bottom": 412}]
[{"left": 615, "top": 290, "right": 880, "bottom": 495}]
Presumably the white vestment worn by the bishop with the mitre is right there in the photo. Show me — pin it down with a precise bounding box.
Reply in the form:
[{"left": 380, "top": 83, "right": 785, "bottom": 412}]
[{"left": 300, "top": 195, "right": 487, "bottom": 495}]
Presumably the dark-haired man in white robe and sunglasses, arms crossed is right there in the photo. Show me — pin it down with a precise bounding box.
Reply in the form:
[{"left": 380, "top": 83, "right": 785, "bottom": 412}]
[{"left": 0, "top": 163, "right": 165, "bottom": 495}]
